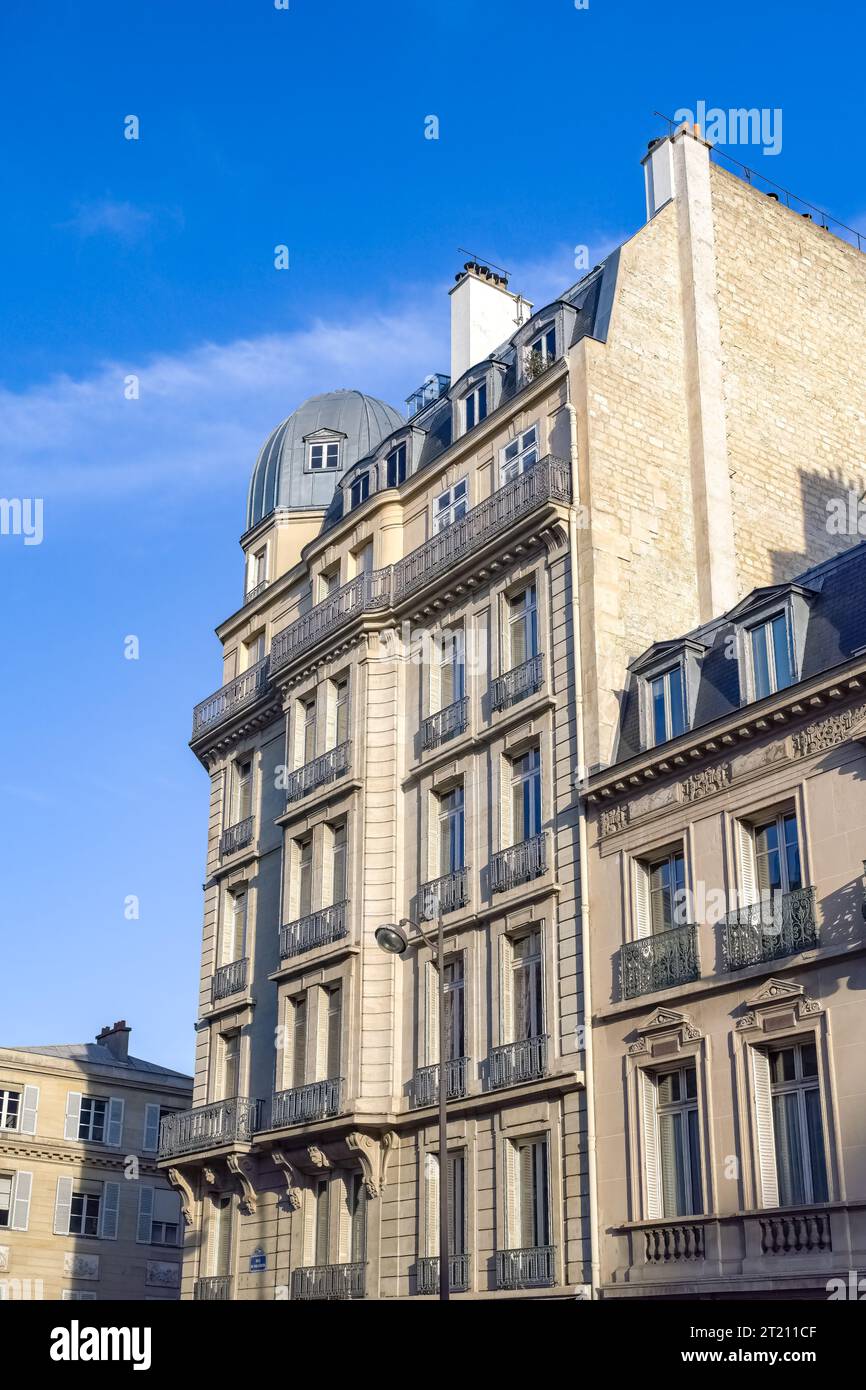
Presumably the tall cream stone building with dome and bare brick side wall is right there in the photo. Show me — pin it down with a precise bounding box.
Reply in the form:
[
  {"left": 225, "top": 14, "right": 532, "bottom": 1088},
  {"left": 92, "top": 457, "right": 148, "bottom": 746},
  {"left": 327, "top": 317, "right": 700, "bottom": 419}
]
[{"left": 161, "top": 122, "right": 866, "bottom": 1300}]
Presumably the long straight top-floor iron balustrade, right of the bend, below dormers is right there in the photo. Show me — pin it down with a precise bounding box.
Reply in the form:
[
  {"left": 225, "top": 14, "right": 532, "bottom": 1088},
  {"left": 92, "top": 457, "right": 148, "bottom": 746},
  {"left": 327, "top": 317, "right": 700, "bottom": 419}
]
[{"left": 391, "top": 455, "right": 571, "bottom": 603}]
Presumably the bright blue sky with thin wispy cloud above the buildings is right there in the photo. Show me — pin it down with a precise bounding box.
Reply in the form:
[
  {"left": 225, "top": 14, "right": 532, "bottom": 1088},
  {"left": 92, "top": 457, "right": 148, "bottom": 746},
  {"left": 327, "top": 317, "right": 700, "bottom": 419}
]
[{"left": 0, "top": 0, "right": 866, "bottom": 1068}]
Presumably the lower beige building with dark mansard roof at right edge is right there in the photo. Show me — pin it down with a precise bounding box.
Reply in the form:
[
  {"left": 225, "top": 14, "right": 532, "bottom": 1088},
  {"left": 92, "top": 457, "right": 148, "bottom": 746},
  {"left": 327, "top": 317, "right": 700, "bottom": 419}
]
[{"left": 589, "top": 545, "right": 866, "bottom": 1298}]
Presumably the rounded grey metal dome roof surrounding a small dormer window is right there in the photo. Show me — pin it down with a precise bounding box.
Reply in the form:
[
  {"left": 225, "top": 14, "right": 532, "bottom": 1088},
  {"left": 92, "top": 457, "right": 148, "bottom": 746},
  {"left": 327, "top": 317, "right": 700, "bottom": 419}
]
[{"left": 246, "top": 391, "right": 406, "bottom": 531}]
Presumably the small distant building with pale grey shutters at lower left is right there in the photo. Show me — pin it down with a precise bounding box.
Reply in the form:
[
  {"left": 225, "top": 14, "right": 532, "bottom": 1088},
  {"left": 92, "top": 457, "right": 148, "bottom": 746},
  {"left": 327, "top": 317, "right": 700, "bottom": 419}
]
[{"left": 0, "top": 1020, "right": 192, "bottom": 1300}]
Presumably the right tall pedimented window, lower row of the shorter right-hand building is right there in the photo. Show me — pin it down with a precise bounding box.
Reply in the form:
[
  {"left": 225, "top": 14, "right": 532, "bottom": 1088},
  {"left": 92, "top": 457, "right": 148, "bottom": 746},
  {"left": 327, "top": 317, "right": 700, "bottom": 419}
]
[{"left": 769, "top": 1043, "right": 827, "bottom": 1207}]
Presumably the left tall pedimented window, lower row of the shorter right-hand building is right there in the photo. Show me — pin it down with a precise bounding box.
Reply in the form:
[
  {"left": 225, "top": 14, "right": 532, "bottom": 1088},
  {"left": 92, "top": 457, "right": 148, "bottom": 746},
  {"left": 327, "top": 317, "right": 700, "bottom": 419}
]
[{"left": 655, "top": 1063, "right": 703, "bottom": 1216}]
